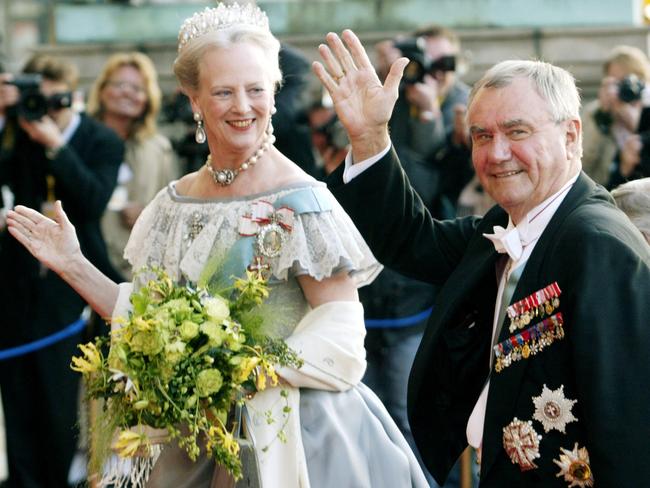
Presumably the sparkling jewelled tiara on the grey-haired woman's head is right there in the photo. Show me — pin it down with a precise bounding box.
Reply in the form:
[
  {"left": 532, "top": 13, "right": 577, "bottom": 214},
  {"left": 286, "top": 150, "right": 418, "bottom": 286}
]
[{"left": 178, "top": 3, "right": 270, "bottom": 51}]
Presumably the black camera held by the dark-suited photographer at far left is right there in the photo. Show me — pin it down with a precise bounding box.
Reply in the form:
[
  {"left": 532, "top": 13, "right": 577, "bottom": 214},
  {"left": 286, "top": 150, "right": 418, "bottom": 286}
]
[{"left": 5, "top": 74, "right": 72, "bottom": 120}]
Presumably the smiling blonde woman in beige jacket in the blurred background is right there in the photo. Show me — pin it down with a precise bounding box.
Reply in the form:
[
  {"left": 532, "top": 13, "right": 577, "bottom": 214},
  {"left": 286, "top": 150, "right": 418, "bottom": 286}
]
[{"left": 88, "top": 52, "right": 178, "bottom": 278}]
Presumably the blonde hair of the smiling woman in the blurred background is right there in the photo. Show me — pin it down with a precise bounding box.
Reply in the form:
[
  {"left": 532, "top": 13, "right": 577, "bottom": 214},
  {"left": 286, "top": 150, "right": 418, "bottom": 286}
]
[{"left": 87, "top": 52, "right": 162, "bottom": 140}]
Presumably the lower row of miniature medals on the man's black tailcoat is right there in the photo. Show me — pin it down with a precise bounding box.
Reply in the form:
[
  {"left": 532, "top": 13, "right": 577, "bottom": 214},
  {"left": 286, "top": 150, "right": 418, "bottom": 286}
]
[{"left": 493, "top": 312, "right": 564, "bottom": 373}]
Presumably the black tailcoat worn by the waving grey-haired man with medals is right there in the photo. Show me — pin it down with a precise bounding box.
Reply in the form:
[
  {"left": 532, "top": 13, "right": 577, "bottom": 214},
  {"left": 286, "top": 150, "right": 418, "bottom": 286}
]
[{"left": 329, "top": 151, "right": 650, "bottom": 487}]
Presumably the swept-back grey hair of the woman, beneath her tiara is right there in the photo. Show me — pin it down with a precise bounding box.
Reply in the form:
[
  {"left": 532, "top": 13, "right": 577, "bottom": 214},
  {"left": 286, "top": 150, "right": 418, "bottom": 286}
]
[{"left": 174, "top": 25, "right": 282, "bottom": 91}]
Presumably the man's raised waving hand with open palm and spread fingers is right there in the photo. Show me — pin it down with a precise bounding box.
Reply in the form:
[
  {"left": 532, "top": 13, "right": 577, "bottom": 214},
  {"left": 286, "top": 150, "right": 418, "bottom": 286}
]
[{"left": 313, "top": 30, "right": 408, "bottom": 162}]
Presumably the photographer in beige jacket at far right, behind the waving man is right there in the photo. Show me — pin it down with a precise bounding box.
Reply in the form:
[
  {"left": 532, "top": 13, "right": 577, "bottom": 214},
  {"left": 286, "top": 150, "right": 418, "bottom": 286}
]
[{"left": 582, "top": 46, "right": 650, "bottom": 187}]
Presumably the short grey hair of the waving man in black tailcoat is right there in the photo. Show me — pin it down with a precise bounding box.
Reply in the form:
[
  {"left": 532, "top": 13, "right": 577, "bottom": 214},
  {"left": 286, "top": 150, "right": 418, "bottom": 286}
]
[{"left": 467, "top": 60, "right": 580, "bottom": 122}]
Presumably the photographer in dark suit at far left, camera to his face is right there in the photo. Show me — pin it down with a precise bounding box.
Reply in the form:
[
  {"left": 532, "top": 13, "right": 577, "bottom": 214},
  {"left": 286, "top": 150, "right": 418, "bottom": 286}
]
[{"left": 0, "top": 56, "right": 124, "bottom": 487}]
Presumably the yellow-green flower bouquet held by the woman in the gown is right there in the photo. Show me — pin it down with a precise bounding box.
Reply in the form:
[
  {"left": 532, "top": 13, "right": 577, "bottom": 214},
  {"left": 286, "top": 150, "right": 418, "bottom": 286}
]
[{"left": 71, "top": 269, "right": 301, "bottom": 479}]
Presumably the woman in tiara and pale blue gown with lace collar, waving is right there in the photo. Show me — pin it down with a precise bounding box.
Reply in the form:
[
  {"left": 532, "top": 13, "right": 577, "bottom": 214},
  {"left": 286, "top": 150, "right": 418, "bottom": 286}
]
[{"left": 8, "top": 4, "right": 427, "bottom": 488}]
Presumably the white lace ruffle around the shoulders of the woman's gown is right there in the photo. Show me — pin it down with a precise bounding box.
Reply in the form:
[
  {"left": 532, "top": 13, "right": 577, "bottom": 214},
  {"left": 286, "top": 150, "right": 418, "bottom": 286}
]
[{"left": 124, "top": 182, "right": 382, "bottom": 286}]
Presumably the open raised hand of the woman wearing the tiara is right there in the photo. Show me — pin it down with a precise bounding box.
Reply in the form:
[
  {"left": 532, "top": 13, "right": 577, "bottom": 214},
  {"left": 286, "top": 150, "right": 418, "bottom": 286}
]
[{"left": 7, "top": 201, "right": 81, "bottom": 274}]
